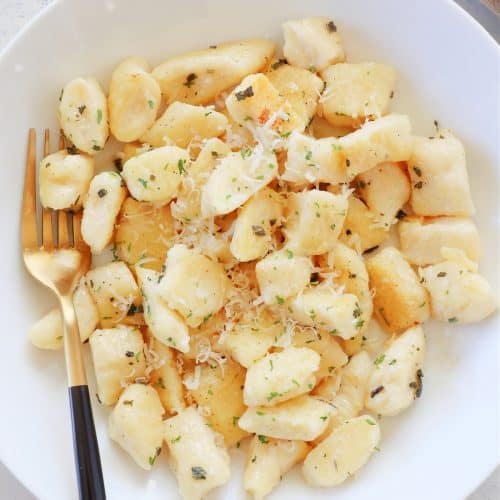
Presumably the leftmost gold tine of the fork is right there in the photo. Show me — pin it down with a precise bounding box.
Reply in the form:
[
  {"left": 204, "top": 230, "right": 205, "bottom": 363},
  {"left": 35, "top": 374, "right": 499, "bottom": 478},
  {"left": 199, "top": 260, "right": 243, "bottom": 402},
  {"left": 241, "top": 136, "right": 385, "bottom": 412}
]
[{"left": 21, "top": 128, "right": 38, "bottom": 249}]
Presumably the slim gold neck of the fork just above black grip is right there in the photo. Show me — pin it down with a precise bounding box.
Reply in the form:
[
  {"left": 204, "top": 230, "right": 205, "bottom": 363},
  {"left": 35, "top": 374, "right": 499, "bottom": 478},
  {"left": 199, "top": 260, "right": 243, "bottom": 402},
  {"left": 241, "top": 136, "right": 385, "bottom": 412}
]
[{"left": 59, "top": 294, "right": 87, "bottom": 387}]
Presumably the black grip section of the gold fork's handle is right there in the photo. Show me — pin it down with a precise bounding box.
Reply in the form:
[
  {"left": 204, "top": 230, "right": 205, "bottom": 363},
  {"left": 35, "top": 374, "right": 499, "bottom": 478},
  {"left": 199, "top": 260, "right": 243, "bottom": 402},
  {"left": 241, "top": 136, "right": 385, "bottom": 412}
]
[{"left": 69, "top": 385, "right": 106, "bottom": 500}]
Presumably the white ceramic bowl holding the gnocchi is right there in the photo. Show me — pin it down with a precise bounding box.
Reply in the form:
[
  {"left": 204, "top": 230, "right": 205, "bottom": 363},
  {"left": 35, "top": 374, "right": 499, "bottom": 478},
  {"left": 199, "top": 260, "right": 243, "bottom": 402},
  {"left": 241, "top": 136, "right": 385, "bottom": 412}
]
[{"left": 0, "top": 0, "right": 500, "bottom": 500}]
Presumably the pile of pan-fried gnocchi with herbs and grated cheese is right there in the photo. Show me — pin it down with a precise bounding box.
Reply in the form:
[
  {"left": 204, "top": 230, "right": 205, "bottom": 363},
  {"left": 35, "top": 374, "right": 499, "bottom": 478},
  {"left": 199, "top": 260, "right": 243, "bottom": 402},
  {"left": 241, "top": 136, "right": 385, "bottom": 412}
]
[{"left": 31, "top": 17, "right": 497, "bottom": 500}]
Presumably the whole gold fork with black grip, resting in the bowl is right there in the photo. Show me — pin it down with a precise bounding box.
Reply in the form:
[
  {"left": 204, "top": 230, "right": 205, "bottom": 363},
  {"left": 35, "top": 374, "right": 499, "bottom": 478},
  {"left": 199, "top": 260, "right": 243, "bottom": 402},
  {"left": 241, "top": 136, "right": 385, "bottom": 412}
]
[{"left": 21, "top": 129, "right": 106, "bottom": 500}]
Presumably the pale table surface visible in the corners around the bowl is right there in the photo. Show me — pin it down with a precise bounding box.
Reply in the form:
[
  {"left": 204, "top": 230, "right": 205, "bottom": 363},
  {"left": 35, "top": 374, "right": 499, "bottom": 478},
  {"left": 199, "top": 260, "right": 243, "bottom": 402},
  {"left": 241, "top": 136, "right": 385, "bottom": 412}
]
[{"left": 0, "top": 0, "right": 500, "bottom": 500}]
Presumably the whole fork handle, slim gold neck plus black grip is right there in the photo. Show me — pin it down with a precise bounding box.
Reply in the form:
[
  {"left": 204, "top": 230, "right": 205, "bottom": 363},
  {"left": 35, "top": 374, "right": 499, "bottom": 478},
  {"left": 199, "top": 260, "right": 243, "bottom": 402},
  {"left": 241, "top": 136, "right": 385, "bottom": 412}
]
[{"left": 60, "top": 294, "right": 106, "bottom": 500}]
